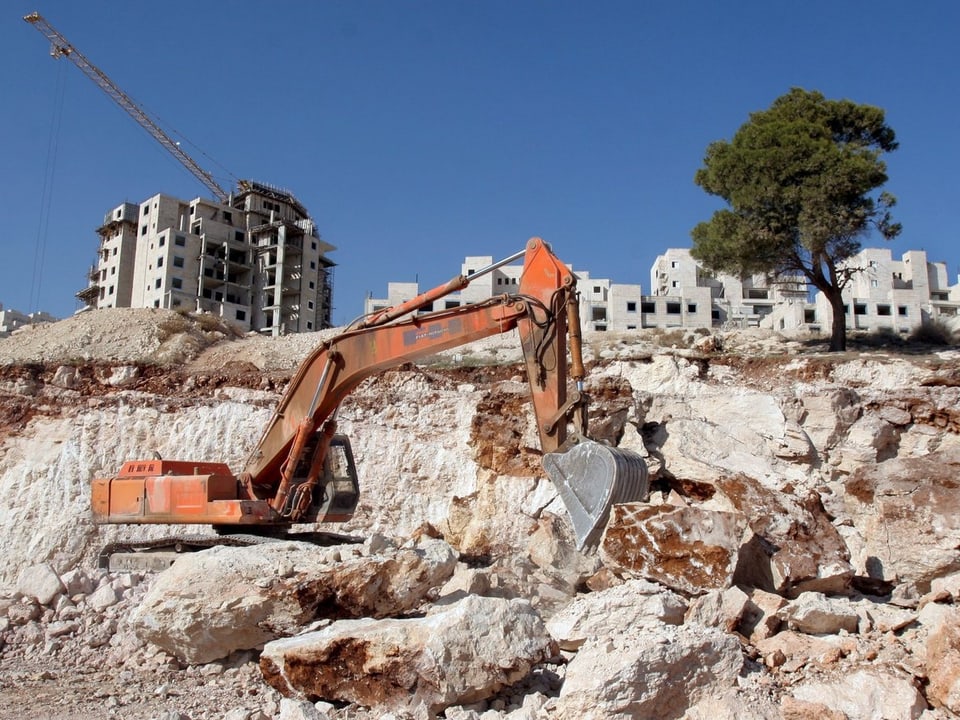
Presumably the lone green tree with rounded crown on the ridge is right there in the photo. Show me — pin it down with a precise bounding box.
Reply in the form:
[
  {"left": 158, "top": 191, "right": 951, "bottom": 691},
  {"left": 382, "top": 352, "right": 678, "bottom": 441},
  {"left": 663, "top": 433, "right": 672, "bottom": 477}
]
[{"left": 691, "top": 88, "right": 900, "bottom": 350}]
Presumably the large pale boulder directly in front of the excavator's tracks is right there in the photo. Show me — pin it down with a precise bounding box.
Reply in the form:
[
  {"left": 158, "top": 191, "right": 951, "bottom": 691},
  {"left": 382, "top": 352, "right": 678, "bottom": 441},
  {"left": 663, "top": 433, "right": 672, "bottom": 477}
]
[{"left": 131, "top": 540, "right": 457, "bottom": 663}]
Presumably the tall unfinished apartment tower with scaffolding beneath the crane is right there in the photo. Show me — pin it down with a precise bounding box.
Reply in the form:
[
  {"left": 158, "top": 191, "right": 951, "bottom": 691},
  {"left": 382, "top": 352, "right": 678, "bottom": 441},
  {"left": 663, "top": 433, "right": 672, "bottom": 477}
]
[{"left": 77, "top": 180, "right": 335, "bottom": 335}]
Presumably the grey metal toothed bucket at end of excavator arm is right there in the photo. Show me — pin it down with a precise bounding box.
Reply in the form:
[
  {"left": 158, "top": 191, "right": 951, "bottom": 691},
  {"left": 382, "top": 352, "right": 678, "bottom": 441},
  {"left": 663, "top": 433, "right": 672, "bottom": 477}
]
[{"left": 543, "top": 440, "right": 648, "bottom": 550}]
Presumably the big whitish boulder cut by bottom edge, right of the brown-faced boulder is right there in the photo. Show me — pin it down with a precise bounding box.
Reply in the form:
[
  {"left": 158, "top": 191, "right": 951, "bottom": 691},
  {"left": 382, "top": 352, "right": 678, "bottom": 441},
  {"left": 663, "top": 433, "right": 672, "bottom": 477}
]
[{"left": 556, "top": 625, "right": 743, "bottom": 720}]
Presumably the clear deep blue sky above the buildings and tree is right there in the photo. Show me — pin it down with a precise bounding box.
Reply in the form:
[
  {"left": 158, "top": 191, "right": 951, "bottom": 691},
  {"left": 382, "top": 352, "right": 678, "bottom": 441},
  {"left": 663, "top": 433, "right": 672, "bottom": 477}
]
[{"left": 0, "top": 0, "right": 960, "bottom": 324}]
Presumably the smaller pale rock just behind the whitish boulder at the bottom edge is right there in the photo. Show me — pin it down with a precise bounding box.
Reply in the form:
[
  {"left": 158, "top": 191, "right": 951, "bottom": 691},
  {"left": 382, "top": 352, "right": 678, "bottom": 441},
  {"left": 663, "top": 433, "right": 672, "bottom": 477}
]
[{"left": 547, "top": 580, "right": 687, "bottom": 650}]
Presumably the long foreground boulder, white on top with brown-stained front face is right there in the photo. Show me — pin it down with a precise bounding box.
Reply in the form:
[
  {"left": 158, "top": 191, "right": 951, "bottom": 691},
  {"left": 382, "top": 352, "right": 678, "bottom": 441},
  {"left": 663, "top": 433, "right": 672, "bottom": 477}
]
[{"left": 260, "top": 596, "right": 556, "bottom": 713}]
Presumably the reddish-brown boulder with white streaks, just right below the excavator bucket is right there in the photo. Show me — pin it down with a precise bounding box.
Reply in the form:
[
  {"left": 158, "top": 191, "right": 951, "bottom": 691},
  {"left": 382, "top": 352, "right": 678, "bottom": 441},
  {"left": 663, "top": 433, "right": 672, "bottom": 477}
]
[{"left": 600, "top": 503, "right": 743, "bottom": 595}]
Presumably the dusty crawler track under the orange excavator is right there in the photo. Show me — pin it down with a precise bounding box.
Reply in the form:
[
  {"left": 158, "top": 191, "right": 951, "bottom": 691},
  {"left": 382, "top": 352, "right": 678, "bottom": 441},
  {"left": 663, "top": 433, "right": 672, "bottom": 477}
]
[{"left": 97, "top": 532, "right": 363, "bottom": 572}]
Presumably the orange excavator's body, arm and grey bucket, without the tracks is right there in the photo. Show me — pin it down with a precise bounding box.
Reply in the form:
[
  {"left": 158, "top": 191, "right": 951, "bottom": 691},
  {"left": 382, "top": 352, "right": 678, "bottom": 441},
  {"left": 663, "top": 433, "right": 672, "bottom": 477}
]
[{"left": 91, "top": 238, "right": 647, "bottom": 560}]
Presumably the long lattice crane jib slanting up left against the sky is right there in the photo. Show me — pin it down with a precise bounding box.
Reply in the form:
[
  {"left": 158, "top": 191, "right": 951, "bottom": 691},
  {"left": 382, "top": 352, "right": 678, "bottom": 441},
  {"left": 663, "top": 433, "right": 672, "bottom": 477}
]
[{"left": 23, "top": 12, "right": 230, "bottom": 204}]
